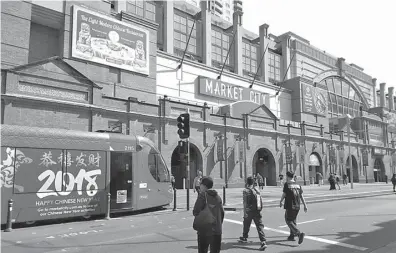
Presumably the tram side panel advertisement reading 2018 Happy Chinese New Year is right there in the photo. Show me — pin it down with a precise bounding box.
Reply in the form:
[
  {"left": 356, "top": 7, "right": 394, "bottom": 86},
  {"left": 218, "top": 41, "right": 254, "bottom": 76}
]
[{"left": 1, "top": 146, "right": 106, "bottom": 222}]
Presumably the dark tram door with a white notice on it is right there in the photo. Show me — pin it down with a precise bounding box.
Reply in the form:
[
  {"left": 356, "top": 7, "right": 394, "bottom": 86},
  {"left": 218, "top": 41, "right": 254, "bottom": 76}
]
[{"left": 110, "top": 152, "right": 133, "bottom": 209}]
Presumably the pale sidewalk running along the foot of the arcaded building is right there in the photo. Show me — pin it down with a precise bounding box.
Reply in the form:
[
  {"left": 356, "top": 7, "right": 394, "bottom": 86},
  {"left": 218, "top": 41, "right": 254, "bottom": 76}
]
[{"left": 169, "top": 183, "right": 394, "bottom": 211}]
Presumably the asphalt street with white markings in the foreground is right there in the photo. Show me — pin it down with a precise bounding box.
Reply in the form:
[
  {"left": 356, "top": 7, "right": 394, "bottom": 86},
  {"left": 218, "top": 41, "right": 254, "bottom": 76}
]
[{"left": 1, "top": 194, "right": 396, "bottom": 253}]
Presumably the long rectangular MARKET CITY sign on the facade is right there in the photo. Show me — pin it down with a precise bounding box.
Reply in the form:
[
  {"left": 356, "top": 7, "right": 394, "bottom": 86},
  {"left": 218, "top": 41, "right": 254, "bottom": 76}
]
[{"left": 198, "top": 76, "right": 269, "bottom": 106}]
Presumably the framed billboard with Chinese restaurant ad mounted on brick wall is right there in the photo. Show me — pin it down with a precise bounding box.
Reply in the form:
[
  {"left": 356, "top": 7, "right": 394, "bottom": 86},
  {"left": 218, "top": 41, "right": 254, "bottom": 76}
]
[{"left": 72, "top": 5, "right": 150, "bottom": 75}]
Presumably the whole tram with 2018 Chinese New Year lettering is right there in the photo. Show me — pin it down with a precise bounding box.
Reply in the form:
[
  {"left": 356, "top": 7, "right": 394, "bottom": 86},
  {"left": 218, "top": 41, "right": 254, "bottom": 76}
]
[{"left": 1, "top": 125, "right": 173, "bottom": 224}]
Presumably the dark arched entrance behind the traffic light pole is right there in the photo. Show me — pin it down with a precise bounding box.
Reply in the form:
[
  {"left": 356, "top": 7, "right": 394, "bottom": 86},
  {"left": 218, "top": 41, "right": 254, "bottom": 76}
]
[{"left": 171, "top": 143, "right": 203, "bottom": 189}]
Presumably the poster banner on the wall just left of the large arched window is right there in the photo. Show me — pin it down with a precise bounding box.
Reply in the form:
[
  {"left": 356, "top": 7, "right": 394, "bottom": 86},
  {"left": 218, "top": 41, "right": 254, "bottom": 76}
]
[{"left": 301, "top": 83, "right": 328, "bottom": 115}]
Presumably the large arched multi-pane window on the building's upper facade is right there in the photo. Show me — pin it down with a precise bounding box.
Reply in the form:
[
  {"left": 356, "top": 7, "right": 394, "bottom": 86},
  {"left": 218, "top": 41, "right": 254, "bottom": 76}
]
[{"left": 321, "top": 76, "right": 363, "bottom": 118}]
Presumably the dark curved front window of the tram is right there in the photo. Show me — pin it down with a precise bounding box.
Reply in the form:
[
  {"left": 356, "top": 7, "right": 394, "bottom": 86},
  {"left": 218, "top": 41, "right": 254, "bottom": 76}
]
[{"left": 146, "top": 142, "right": 170, "bottom": 182}]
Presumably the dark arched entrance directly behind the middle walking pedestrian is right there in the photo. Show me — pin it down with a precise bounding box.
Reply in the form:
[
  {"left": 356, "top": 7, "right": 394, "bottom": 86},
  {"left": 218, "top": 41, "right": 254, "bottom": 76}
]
[{"left": 252, "top": 148, "right": 277, "bottom": 186}]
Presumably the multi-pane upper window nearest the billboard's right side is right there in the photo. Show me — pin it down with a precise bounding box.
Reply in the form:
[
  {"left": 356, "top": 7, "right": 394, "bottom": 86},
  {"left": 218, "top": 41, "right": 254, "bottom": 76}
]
[{"left": 173, "top": 13, "right": 197, "bottom": 55}]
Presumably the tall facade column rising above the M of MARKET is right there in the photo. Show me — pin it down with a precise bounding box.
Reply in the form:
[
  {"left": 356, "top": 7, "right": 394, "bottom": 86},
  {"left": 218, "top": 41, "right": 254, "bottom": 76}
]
[{"left": 197, "top": 1, "right": 212, "bottom": 66}]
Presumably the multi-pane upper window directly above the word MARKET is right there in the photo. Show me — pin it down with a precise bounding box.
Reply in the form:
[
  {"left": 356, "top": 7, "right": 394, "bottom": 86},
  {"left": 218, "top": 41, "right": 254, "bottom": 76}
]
[{"left": 212, "top": 29, "right": 230, "bottom": 65}]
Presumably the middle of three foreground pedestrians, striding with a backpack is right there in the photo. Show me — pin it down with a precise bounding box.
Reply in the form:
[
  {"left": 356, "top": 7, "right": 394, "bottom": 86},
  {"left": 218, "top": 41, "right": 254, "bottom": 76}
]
[{"left": 239, "top": 177, "right": 267, "bottom": 251}]
